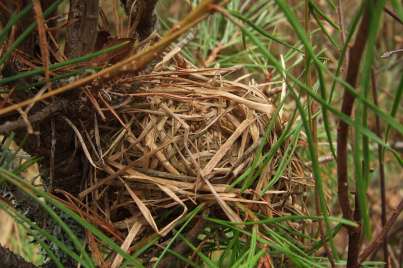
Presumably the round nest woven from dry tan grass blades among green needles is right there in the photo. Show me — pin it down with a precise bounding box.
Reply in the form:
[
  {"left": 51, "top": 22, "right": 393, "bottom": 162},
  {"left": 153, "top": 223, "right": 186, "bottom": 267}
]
[{"left": 80, "top": 62, "right": 309, "bottom": 239}]
